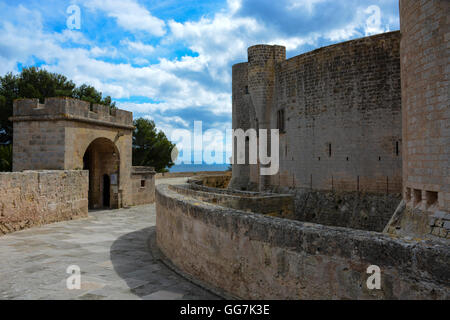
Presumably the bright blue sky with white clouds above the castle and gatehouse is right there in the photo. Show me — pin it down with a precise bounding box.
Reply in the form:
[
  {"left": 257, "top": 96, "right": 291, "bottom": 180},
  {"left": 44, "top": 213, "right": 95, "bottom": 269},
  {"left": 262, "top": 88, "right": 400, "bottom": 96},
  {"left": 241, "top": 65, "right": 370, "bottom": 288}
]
[{"left": 0, "top": 0, "right": 399, "bottom": 155}]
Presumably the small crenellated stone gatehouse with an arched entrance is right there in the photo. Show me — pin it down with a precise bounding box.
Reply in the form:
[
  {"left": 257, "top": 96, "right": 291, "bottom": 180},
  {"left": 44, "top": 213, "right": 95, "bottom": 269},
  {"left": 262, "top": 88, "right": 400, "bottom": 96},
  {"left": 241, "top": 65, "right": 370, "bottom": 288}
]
[{"left": 11, "top": 98, "right": 154, "bottom": 209}]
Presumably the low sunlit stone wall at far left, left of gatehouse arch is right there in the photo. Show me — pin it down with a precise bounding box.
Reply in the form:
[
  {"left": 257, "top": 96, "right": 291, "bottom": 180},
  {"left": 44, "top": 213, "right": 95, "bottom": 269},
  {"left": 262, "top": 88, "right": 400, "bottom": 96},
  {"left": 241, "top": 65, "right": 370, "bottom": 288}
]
[{"left": 0, "top": 170, "right": 88, "bottom": 235}]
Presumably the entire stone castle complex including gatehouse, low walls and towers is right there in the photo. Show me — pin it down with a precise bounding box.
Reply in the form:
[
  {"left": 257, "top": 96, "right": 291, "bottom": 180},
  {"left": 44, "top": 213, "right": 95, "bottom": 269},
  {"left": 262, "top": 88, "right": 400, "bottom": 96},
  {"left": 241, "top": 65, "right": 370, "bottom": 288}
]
[{"left": 0, "top": 0, "right": 450, "bottom": 300}]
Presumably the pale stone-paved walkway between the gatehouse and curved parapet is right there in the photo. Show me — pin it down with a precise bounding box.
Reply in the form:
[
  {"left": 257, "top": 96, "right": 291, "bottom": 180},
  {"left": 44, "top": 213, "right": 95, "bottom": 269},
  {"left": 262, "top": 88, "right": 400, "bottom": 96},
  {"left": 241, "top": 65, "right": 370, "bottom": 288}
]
[{"left": 0, "top": 179, "right": 217, "bottom": 300}]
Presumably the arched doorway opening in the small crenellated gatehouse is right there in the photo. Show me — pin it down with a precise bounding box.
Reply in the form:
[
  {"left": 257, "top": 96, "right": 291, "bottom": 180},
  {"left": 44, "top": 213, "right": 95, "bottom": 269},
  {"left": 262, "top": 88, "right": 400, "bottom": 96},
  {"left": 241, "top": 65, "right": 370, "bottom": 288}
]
[{"left": 83, "top": 138, "right": 120, "bottom": 209}]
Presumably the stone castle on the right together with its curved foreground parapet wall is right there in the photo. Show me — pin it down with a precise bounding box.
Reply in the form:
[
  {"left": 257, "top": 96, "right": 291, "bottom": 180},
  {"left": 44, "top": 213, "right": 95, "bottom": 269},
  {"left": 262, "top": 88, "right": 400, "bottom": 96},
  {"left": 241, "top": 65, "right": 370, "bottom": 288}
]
[{"left": 156, "top": 0, "right": 450, "bottom": 300}]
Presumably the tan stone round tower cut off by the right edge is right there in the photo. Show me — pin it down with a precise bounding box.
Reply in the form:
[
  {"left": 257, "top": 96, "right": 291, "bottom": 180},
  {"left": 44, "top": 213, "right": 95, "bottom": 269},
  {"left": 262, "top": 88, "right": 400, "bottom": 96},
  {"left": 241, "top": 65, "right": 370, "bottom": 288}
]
[{"left": 400, "top": 0, "right": 450, "bottom": 215}]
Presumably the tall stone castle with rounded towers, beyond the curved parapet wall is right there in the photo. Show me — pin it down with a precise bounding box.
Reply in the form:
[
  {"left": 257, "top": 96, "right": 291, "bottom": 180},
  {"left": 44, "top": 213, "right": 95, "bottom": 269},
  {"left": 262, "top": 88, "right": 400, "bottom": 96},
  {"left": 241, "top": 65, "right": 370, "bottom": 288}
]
[{"left": 230, "top": 1, "right": 450, "bottom": 238}]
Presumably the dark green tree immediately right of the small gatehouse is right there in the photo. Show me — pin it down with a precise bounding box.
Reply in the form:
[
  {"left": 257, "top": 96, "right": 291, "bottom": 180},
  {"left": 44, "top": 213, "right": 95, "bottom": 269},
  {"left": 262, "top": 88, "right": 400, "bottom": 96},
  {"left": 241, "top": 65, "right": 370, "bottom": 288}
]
[{"left": 133, "top": 118, "right": 175, "bottom": 172}]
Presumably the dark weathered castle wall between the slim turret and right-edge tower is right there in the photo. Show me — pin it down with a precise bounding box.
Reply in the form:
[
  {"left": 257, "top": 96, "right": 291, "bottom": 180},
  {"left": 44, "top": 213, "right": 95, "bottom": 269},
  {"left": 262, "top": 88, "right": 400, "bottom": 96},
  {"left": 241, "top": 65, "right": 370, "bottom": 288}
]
[{"left": 271, "top": 32, "right": 402, "bottom": 194}]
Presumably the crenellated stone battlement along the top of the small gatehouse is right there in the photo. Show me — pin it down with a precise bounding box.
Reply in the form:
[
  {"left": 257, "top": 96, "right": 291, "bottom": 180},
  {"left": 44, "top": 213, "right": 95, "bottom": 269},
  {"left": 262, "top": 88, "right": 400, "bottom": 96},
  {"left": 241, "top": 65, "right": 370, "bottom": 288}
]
[{"left": 11, "top": 97, "right": 133, "bottom": 129}]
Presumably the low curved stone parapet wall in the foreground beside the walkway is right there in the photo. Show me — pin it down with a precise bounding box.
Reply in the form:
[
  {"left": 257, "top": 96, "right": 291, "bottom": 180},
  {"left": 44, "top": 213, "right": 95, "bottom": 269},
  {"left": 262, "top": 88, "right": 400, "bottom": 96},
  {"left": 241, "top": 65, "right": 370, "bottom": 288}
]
[{"left": 156, "top": 185, "right": 450, "bottom": 299}]
